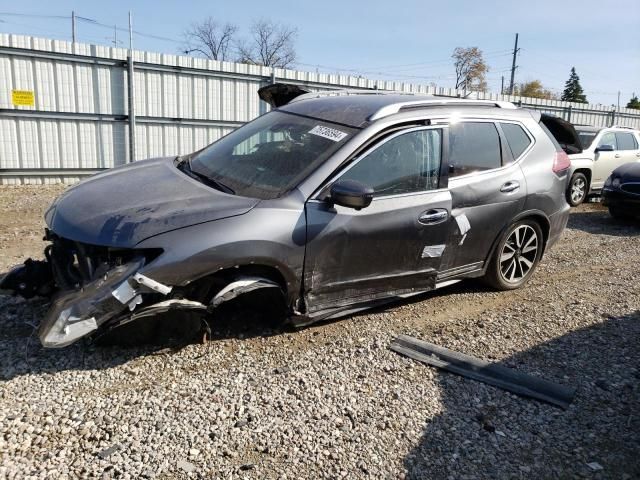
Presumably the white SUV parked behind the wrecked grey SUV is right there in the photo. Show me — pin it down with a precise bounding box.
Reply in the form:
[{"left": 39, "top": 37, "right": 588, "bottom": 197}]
[{"left": 567, "top": 126, "right": 640, "bottom": 206}]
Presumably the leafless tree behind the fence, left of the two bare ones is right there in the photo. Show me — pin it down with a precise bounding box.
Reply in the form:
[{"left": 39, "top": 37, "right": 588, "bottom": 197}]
[{"left": 184, "top": 17, "right": 238, "bottom": 60}]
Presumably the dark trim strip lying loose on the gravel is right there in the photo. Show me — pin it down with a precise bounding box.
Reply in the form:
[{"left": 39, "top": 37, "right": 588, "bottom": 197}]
[{"left": 389, "top": 335, "right": 576, "bottom": 409}]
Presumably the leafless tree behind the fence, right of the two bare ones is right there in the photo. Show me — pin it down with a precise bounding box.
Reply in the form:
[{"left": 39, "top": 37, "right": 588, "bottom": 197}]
[{"left": 236, "top": 19, "right": 298, "bottom": 68}]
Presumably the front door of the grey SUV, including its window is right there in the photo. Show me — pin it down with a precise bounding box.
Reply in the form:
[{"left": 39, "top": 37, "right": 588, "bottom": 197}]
[{"left": 304, "top": 127, "right": 451, "bottom": 314}]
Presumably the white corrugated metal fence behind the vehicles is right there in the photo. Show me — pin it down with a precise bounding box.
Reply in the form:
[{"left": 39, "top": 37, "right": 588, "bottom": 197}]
[{"left": 0, "top": 34, "right": 640, "bottom": 183}]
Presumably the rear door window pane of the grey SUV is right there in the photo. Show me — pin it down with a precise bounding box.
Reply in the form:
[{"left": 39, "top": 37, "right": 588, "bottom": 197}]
[{"left": 449, "top": 122, "right": 502, "bottom": 177}]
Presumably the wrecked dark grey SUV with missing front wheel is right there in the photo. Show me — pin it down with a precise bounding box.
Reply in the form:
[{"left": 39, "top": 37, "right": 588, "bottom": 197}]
[{"left": 0, "top": 84, "right": 578, "bottom": 347}]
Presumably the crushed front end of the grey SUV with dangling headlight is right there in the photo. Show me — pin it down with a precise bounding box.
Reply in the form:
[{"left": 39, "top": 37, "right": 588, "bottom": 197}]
[{"left": 0, "top": 230, "right": 182, "bottom": 348}]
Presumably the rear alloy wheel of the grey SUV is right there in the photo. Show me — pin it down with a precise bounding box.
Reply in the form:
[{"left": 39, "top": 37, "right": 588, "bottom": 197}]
[{"left": 500, "top": 225, "right": 540, "bottom": 283}]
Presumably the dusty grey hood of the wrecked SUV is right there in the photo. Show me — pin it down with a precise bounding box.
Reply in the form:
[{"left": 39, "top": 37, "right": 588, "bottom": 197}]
[{"left": 45, "top": 158, "right": 259, "bottom": 248}]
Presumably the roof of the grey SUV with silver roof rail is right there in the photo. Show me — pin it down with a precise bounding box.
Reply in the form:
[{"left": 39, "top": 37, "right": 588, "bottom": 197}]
[{"left": 279, "top": 90, "right": 522, "bottom": 128}]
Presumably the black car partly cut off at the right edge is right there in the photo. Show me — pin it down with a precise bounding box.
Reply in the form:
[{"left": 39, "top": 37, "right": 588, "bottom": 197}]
[{"left": 602, "top": 162, "right": 640, "bottom": 219}]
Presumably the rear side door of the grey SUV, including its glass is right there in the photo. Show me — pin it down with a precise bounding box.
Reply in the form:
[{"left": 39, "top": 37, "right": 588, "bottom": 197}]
[{"left": 438, "top": 120, "right": 533, "bottom": 281}]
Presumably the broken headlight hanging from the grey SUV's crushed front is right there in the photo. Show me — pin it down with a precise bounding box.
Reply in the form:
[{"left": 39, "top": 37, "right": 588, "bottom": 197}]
[{"left": 38, "top": 258, "right": 144, "bottom": 348}]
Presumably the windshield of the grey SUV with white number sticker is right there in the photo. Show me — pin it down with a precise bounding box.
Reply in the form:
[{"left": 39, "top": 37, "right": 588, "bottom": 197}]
[{"left": 190, "top": 111, "right": 355, "bottom": 199}]
